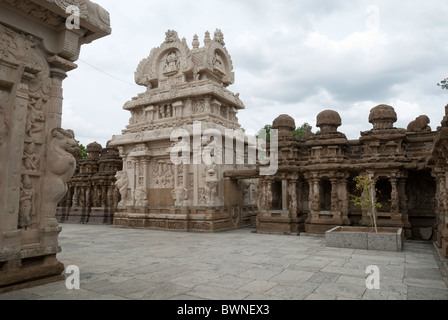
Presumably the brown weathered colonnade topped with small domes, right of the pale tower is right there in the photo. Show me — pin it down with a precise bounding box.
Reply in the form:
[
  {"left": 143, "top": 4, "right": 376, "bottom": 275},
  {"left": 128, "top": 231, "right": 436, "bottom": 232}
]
[{"left": 226, "top": 105, "right": 440, "bottom": 240}]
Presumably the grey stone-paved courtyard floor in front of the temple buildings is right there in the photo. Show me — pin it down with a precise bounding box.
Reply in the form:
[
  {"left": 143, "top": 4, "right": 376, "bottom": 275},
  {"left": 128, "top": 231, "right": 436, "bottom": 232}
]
[{"left": 0, "top": 224, "right": 448, "bottom": 300}]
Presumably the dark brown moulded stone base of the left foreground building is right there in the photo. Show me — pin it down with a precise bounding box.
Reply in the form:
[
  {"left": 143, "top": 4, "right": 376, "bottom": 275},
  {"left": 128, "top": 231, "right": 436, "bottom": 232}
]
[{"left": 0, "top": 252, "right": 65, "bottom": 293}]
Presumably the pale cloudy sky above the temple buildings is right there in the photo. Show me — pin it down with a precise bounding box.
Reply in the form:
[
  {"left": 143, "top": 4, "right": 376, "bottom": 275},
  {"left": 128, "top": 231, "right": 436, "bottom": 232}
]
[{"left": 62, "top": 0, "right": 448, "bottom": 146}]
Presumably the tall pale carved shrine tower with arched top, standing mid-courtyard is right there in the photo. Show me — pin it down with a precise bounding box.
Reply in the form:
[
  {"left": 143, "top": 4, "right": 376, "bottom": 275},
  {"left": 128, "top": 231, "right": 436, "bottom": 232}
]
[{"left": 111, "top": 30, "right": 256, "bottom": 231}]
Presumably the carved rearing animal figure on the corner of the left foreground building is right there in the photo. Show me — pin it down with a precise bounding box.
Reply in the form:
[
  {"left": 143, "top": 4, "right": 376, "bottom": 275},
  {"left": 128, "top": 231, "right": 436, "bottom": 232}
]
[{"left": 41, "top": 128, "right": 78, "bottom": 227}]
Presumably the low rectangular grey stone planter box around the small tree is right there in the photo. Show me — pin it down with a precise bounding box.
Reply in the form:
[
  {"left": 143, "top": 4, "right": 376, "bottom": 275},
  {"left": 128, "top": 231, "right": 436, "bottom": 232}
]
[{"left": 325, "top": 226, "right": 404, "bottom": 252}]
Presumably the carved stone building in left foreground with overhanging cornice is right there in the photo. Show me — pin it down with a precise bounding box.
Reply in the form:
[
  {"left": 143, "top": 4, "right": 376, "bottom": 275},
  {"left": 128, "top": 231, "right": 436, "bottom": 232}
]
[{"left": 0, "top": 0, "right": 110, "bottom": 292}]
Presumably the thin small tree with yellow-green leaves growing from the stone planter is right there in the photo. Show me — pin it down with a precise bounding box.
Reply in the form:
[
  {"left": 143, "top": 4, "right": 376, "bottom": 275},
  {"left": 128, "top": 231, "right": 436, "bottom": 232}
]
[{"left": 350, "top": 175, "right": 381, "bottom": 233}]
